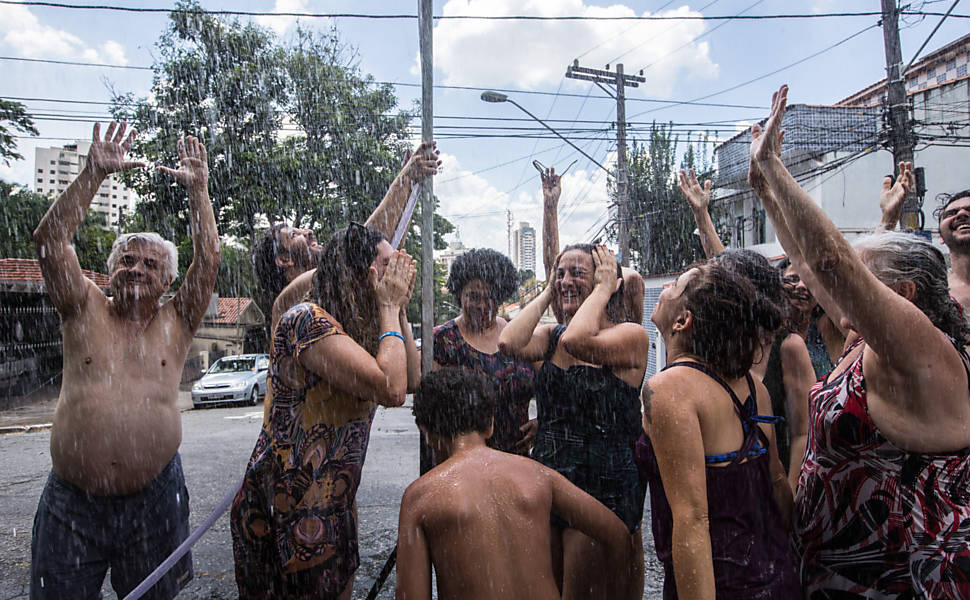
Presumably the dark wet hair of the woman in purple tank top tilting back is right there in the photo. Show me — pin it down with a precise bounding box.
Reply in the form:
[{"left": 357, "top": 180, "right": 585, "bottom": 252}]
[{"left": 683, "top": 260, "right": 782, "bottom": 379}]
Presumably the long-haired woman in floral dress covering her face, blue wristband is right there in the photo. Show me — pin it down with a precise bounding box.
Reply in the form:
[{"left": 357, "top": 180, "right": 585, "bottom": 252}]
[{"left": 231, "top": 224, "right": 418, "bottom": 598}]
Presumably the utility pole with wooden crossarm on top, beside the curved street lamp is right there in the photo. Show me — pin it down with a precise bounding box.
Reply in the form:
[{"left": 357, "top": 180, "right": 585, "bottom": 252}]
[{"left": 566, "top": 59, "right": 647, "bottom": 267}]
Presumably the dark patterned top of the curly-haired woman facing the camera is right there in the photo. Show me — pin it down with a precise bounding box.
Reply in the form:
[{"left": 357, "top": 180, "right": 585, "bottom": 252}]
[{"left": 434, "top": 319, "right": 536, "bottom": 454}]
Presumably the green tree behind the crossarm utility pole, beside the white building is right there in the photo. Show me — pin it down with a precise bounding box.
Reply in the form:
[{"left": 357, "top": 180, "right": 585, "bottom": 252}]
[{"left": 610, "top": 123, "right": 728, "bottom": 275}]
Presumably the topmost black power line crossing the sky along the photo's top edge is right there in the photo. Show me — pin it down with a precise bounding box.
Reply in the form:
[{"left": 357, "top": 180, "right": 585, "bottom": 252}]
[{"left": 0, "top": 0, "right": 970, "bottom": 21}]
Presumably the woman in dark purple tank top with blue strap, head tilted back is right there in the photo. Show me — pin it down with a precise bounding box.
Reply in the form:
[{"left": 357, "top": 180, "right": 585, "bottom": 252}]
[{"left": 636, "top": 261, "right": 801, "bottom": 600}]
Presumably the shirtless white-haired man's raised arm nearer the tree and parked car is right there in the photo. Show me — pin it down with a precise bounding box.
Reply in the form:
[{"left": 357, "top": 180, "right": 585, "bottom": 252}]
[{"left": 164, "top": 135, "right": 222, "bottom": 332}]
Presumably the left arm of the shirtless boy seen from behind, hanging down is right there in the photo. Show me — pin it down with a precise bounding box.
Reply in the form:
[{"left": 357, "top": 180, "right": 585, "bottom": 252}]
[{"left": 394, "top": 487, "right": 431, "bottom": 600}]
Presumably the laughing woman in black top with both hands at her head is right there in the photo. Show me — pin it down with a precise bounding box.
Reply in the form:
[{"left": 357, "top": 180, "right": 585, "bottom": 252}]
[{"left": 499, "top": 244, "right": 650, "bottom": 598}]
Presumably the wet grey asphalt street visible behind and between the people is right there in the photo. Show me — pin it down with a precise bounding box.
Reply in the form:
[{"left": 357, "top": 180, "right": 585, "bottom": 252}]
[{"left": 0, "top": 407, "right": 662, "bottom": 600}]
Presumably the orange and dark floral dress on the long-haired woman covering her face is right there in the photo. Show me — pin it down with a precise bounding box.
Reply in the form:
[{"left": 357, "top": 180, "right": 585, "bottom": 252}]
[{"left": 231, "top": 303, "right": 375, "bottom": 599}]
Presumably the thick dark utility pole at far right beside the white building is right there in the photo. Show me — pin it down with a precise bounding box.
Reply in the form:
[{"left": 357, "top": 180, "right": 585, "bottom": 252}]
[{"left": 882, "top": 0, "right": 920, "bottom": 231}]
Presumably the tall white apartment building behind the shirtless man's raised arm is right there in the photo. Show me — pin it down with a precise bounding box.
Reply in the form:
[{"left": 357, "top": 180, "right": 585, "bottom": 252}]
[{"left": 34, "top": 141, "right": 138, "bottom": 228}]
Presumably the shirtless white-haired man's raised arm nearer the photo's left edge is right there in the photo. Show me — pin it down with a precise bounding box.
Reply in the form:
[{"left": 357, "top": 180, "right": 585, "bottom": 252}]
[{"left": 34, "top": 122, "right": 145, "bottom": 318}]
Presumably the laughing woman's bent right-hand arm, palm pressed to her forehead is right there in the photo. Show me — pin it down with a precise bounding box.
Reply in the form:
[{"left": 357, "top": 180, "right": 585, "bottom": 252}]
[{"left": 561, "top": 246, "right": 650, "bottom": 369}]
